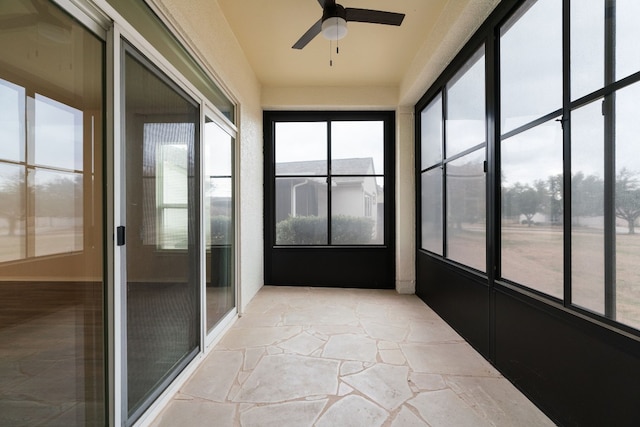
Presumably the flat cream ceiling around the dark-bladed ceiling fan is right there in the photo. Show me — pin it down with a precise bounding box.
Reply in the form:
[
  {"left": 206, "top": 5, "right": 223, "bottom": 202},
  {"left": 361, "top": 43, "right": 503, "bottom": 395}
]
[{"left": 218, "top": 0, "right": 452, "bottom": 87}]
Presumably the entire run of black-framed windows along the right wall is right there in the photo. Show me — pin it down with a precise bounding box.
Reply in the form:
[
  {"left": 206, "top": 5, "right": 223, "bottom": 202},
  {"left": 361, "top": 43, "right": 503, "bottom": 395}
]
[{"left": 416, "top": 0, "right": 640, "bottom": 331}]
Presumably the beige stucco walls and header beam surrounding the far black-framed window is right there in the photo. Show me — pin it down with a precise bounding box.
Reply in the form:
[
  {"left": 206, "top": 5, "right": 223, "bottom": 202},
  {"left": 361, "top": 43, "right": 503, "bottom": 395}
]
[{"left": 154, "top": 0, "right": 499, "bottom": 298}]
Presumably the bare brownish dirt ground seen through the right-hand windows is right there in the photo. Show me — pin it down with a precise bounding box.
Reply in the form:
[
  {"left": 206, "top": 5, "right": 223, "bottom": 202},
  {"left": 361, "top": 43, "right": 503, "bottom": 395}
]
[{"left": 448, "top": 224, "right": 640, "bottom": 329}]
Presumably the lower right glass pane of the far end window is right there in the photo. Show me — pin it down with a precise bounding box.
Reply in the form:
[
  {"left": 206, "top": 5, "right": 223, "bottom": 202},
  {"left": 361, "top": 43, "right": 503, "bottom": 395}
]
[{"left": 331, "top": 176, "right": 384, "bottom": 245}]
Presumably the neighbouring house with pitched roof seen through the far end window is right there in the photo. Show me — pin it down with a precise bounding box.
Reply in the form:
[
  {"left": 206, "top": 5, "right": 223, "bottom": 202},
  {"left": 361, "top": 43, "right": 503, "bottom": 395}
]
[{"left": 276, "top": 157, "right": 384, "bottom": 241}]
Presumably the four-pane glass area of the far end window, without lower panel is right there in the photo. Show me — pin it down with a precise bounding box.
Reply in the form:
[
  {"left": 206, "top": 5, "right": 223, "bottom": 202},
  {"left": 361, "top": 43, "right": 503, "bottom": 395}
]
[{"left": 275, "top": 120, "right": 385, "bottom": 245}]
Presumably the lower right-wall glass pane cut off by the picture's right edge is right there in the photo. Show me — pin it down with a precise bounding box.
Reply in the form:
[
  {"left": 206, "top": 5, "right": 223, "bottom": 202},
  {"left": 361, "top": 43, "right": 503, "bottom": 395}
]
[{"left": 615, "top": 83, "right": 640, "bottom": 328}]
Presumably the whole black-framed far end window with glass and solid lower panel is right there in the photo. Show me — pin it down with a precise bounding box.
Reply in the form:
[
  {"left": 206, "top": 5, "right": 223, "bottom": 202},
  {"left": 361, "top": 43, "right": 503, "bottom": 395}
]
[{"left": 264, "top": 111, "right": 395, "bottom": 288}]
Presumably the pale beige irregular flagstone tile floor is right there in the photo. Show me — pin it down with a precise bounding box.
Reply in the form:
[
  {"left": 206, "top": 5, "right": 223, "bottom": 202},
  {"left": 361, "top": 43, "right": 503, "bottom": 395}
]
[{"left": 152, "top": 286, "right": 553, "bottom": 427}]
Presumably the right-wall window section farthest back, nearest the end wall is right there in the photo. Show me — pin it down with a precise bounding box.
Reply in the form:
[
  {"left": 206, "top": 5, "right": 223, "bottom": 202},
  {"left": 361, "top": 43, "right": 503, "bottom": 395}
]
[{"left": 420, "top": 48, "right": 487, "bottom": 271}]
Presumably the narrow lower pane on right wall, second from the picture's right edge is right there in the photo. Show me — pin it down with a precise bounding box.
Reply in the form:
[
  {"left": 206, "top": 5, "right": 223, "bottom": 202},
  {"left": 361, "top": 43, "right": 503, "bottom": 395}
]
[{"left": 571, "top": 100, "right": 605, "bottom": 314}]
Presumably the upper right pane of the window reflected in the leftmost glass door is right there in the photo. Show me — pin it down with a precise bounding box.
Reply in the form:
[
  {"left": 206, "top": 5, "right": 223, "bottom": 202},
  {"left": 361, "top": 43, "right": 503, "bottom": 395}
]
[{"left": 35, "top": 94, "right": 82, "bottom": 171}]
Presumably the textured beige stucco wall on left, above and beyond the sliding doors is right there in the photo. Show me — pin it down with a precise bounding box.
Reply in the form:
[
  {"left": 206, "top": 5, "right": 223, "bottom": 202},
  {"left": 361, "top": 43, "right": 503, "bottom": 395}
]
[{"left": 154, "top": 0, "right": 264, "bottom": 311}]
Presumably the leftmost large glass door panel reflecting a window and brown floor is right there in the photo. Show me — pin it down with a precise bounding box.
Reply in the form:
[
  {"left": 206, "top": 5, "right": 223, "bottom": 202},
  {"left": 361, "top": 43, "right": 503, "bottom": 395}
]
[{"left": 0, "top": 0, "right": 107, "bottom": 426}]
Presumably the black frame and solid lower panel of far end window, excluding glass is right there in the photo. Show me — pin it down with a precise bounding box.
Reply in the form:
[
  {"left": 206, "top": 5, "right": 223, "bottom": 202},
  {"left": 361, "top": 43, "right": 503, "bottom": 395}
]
[{"left": 263, "top": 110, "right": 396, "bottom": 289}]
